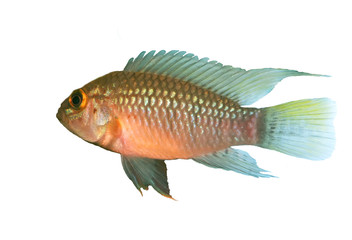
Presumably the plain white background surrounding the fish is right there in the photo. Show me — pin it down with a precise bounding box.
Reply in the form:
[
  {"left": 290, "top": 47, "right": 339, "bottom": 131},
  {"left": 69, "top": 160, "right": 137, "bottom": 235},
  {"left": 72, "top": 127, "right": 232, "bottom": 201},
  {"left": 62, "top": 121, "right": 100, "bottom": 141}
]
[{"left": 0, "top": 0, "right": 352, "bottom": 240}]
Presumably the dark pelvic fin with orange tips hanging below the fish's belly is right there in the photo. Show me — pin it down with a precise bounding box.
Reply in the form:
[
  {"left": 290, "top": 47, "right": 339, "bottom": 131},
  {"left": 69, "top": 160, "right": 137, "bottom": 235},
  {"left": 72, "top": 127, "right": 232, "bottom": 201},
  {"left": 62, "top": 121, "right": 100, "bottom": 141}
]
[{"left": 122, "top": 156, "right": 172, "bottom": 198}]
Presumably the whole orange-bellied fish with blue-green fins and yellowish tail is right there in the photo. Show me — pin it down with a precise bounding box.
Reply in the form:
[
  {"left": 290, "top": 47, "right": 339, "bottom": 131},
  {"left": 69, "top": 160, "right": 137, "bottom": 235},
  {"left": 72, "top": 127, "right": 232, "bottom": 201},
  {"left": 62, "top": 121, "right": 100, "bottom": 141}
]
[{"left": 56, "top": 50, "right": 336, "bottom": 199}]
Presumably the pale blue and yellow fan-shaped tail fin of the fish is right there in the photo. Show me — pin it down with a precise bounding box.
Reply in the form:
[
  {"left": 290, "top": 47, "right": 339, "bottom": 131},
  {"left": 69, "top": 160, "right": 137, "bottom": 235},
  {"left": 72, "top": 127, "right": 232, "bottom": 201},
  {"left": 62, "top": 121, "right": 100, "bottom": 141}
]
[{"left": 257, "top": 98, "right": 336, "bottom": 160}]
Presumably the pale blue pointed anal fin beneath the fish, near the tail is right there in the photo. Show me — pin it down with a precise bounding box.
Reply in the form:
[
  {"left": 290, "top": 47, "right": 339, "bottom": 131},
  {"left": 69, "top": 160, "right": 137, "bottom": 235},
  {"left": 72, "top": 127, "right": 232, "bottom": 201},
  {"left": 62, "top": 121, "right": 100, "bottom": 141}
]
[{"left": 193, "top": 148, "right": 273, "bottom": 178}]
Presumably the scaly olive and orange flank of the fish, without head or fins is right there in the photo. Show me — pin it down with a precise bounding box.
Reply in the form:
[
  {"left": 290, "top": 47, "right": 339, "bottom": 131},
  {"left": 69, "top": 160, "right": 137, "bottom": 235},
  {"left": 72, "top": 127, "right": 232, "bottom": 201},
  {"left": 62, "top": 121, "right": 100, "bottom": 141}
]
[{"left": 85, "top": 72, "right": 258, "bottom": 159}]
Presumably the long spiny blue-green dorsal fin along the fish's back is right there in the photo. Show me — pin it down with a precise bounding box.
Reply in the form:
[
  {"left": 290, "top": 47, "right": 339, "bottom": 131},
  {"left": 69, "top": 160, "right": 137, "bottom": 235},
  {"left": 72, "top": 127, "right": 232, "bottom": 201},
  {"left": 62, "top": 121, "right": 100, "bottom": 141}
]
[{"left": 124, "top": 50, "right": 323, "bottom": 105}]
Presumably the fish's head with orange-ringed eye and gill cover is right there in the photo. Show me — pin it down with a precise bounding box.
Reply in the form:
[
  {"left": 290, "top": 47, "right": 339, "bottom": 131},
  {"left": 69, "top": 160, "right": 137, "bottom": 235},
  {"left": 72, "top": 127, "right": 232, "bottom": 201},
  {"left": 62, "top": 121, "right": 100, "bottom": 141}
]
[{"left": 56, "top": 88, "right": 110, "bottom": 143}]
